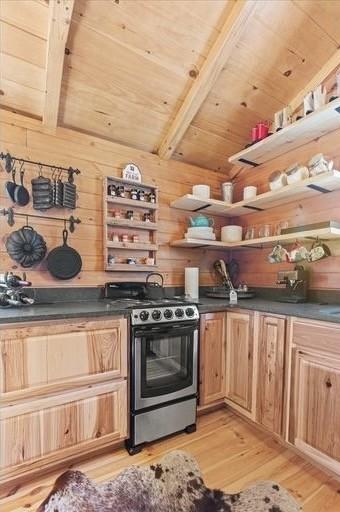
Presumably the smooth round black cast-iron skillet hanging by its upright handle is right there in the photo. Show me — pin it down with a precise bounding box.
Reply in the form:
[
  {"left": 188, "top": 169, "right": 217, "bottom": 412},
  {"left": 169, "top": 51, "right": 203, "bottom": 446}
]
[{"left": 47, "top": 229, "right": 82, "bottom": 280}]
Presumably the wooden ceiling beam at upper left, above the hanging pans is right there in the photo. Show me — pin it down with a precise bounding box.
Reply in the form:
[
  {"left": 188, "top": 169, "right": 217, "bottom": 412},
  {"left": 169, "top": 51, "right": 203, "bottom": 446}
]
[{"left": 43, "top": 0, "right": 74, "bottom": 130}]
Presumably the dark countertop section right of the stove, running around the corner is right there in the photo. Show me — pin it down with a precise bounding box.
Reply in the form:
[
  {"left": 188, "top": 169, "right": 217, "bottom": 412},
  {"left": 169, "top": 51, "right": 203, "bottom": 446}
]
[{"left": 199, "top": 297, "right": 340, "bottom": 323}]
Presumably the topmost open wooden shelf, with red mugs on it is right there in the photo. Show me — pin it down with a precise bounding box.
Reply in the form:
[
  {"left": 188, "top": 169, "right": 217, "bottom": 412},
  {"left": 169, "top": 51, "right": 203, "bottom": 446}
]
[{"left": 229, "top": 99, "right": 340, "bottom": 167}]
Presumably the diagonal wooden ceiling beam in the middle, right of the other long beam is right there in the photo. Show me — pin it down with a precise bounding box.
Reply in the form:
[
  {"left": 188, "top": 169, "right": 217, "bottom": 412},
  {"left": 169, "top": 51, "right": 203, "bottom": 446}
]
[{"left": 158, "top": 0, "right": 256, "bottom": 159}]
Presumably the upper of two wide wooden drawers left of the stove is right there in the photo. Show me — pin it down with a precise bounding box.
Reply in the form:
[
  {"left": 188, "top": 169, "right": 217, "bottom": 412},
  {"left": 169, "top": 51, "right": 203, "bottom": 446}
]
[{"left": 0, "top": 319, "right": 127, "bottom": 396}]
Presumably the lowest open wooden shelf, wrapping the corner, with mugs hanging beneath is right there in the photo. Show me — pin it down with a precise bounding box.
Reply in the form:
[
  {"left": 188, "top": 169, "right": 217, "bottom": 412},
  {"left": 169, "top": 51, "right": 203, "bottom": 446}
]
[{"left": 171, "top": 227, "right": 340, "bottom": 250}]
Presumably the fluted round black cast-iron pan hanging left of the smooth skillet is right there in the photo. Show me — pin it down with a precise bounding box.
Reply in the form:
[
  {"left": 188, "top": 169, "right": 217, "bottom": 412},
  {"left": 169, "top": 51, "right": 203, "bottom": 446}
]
[{"left": 5, "top": 226, "right": 47, "bottom": 268}]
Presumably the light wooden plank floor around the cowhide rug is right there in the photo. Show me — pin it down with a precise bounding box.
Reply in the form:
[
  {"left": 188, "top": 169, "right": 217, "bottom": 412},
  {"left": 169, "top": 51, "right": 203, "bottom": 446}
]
[{"left": 0, "top": 409, "right": 340, "bottom": 512}]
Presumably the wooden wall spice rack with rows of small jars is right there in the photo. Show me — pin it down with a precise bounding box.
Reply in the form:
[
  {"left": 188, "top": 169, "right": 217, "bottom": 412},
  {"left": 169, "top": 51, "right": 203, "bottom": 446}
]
[{"left": 103, "top": 177, "right": 158, "bottom": 272}]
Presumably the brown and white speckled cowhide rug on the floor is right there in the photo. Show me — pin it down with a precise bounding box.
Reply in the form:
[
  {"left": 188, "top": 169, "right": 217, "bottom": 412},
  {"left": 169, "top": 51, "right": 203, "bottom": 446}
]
[{"left": 37, "top": 451, "right": 300, "bottom": 512}]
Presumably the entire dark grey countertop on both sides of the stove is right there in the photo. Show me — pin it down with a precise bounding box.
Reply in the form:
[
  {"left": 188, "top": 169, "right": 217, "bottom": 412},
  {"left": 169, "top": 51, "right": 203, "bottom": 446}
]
[{"left": 0, "top": 297, "right": 340, "bottom": 324}]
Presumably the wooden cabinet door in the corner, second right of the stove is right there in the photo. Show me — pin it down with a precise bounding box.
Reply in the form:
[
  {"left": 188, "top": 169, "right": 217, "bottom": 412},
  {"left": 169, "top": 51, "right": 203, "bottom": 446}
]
[{"left": 226, "top": 312, "right": 254, "bottom": 412}]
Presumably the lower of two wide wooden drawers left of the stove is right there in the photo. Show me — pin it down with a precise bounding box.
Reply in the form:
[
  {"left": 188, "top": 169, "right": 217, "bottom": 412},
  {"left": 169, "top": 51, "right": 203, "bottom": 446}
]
[{"left": 0, "top": 380, "right": 127, "bottom": 476}]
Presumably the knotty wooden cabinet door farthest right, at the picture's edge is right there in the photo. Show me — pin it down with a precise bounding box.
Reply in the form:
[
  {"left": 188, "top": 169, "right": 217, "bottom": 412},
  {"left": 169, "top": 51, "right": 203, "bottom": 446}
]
[{"left": 290, "top": 350, "right": 340, "bottom": 474}]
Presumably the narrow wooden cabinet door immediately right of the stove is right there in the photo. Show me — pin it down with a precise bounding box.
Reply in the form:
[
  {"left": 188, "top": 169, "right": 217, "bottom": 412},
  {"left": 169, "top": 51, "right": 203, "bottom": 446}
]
[{"left": 200, "top": 313, "right": 226, "bottom": 405}]
